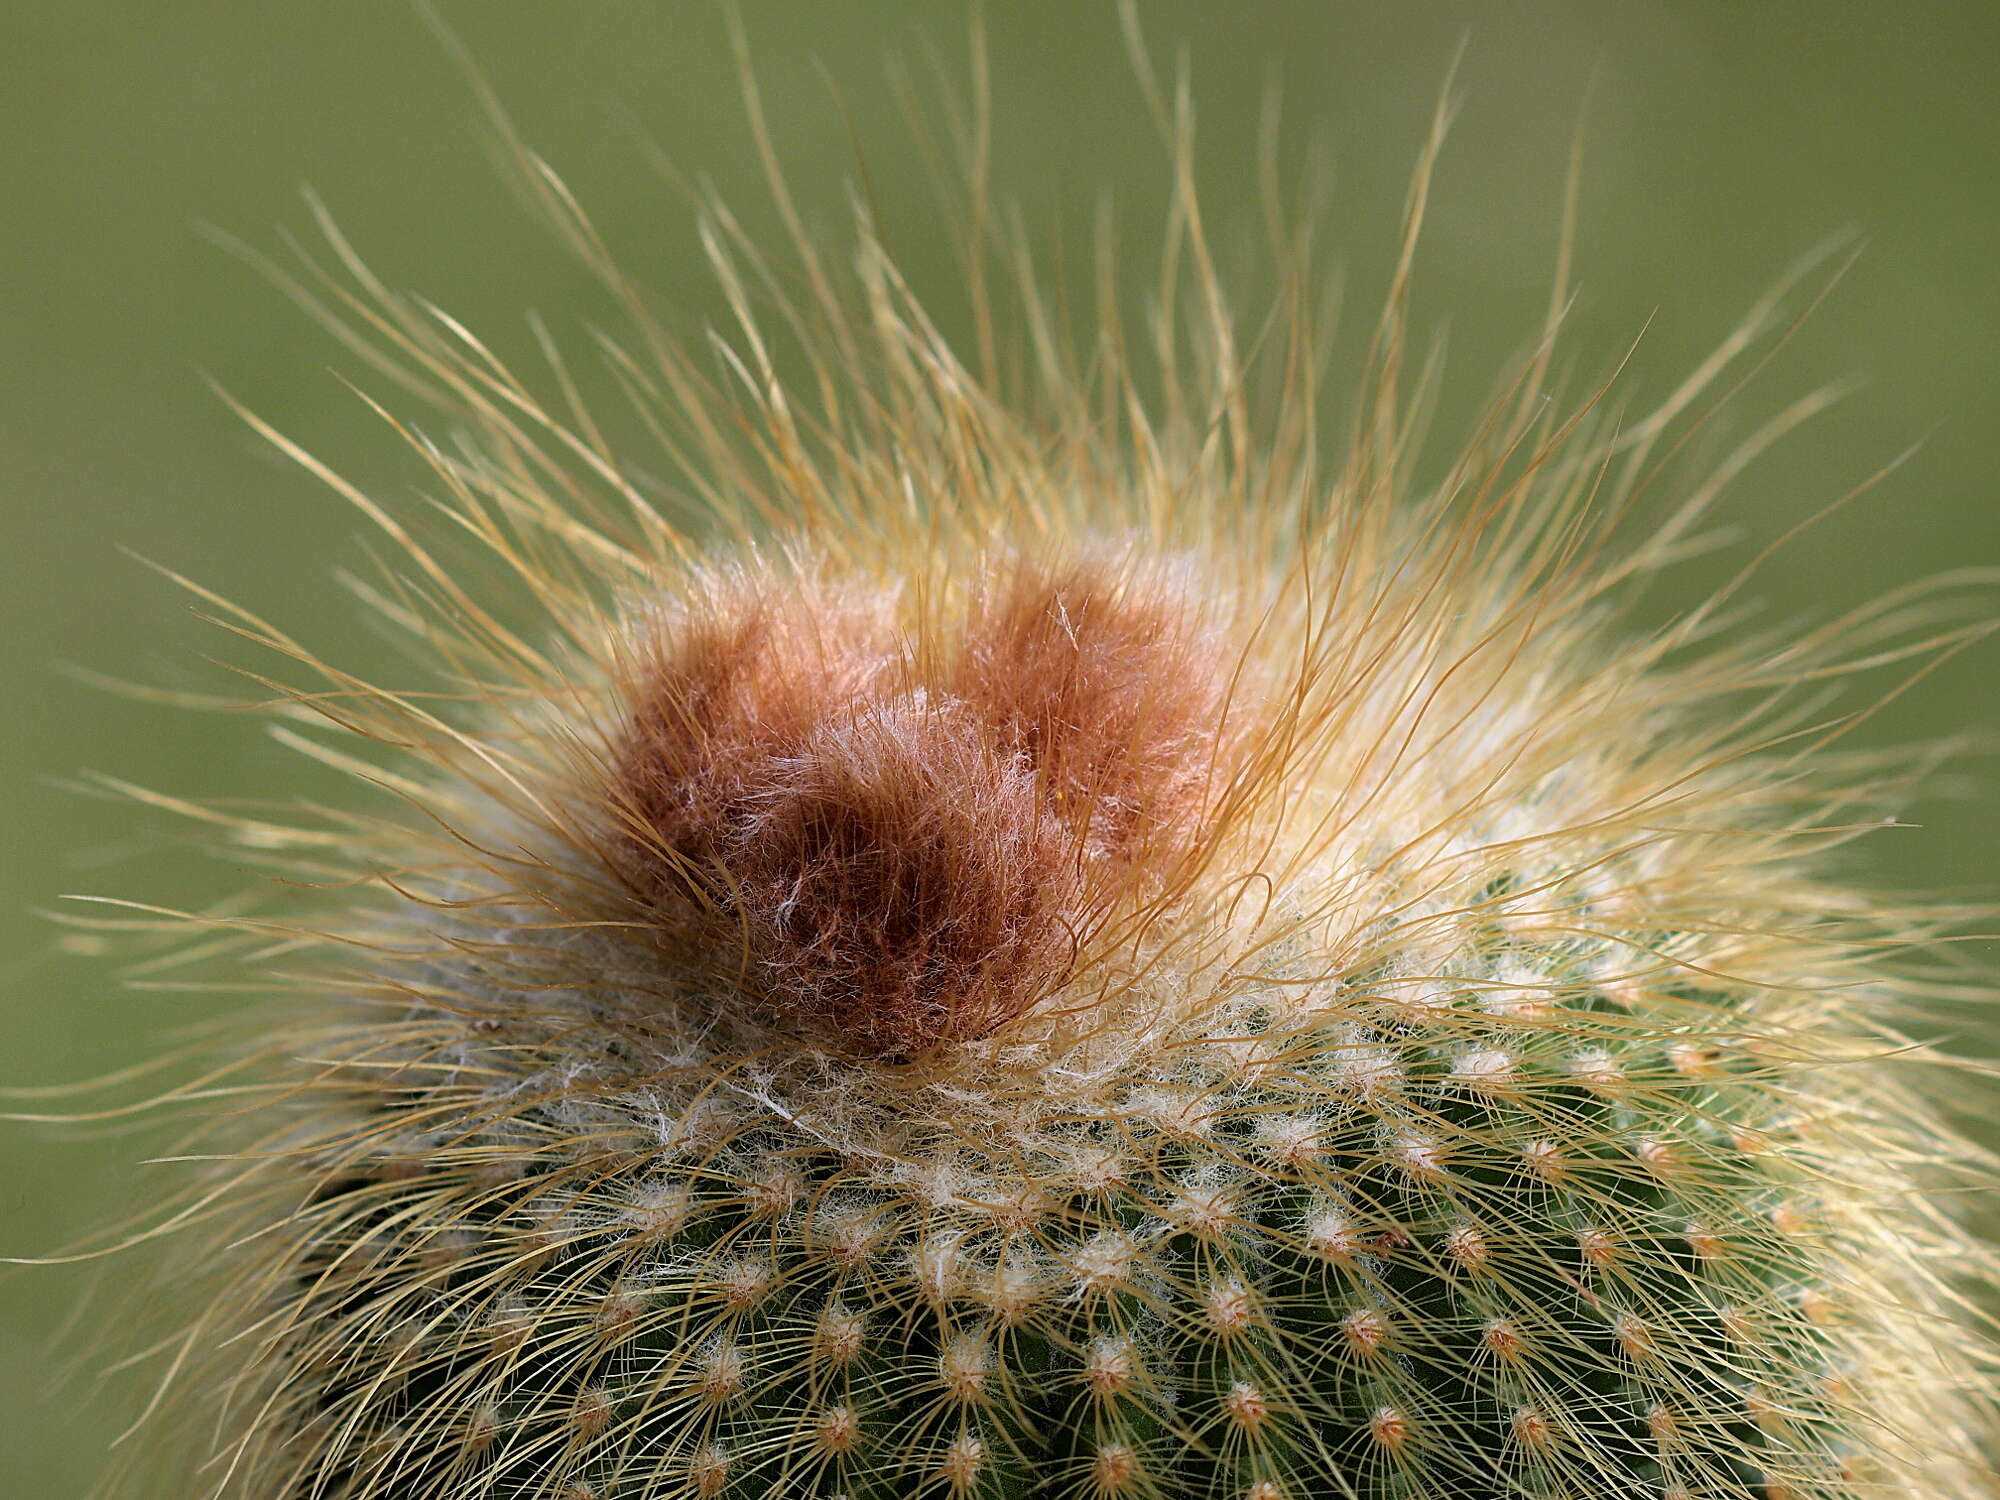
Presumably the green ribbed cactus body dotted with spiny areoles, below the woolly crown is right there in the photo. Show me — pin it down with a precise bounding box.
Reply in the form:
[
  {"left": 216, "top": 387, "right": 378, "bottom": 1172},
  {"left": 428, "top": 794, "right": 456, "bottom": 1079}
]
[{"left": 292, "top": 936, "right": 1840, "bottom": 1500}]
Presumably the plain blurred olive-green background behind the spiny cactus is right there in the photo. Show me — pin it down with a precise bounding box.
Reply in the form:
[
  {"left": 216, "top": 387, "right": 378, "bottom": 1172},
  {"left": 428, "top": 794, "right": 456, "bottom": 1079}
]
[{"left": 0, "top": 0, "right": 2000, "bottom": 1500}]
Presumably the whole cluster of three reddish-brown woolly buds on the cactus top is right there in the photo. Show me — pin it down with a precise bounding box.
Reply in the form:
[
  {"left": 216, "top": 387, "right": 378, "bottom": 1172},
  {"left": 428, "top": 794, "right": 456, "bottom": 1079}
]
[{"left": 604, "top": 560, "right": 1228, "bottom": 1056}]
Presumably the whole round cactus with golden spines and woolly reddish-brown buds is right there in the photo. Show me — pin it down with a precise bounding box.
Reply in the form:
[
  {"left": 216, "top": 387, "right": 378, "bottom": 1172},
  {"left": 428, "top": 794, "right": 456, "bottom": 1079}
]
[{"left": 54, "top": 23, "right": 1992, "bottom": 1500}]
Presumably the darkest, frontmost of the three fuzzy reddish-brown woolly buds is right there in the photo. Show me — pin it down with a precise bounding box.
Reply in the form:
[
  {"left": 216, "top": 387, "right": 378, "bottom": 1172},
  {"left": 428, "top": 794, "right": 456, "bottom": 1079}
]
[{"left": 732, "top": 700, "right": 1082, "bottom": 1054}]
